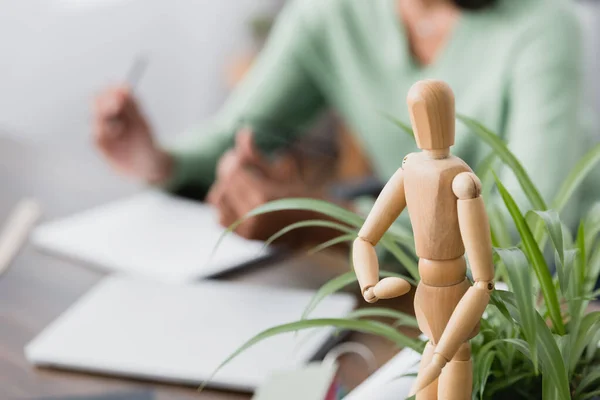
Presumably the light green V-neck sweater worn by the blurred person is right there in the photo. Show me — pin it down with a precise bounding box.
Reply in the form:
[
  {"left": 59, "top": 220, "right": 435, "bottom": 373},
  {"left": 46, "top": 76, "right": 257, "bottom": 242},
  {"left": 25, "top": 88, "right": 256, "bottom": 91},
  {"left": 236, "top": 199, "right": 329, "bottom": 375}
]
[{"left": 169, "top": 0, "right": 587, "bottom": 225}]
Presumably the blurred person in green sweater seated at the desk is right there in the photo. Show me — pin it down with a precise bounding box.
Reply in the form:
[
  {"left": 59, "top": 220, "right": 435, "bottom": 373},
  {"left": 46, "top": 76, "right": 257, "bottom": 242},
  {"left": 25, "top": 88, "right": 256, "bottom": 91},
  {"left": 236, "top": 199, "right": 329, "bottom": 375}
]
[{"left": 94, "top": 0, "right": 586, "bottom": 244}]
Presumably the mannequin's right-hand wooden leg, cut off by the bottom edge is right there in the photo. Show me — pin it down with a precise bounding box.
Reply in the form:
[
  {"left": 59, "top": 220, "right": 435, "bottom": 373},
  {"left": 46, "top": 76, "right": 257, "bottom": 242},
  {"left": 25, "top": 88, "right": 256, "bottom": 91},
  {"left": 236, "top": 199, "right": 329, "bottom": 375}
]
[{"left": 438, "top": 343, "right": 473, "bottom": 400}]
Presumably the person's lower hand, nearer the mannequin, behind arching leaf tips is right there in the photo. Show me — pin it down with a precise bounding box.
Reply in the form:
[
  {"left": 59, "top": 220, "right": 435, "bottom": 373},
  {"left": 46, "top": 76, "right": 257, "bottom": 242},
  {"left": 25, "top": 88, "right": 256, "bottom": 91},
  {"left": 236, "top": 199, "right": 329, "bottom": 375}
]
[{"left": 207, "top": 130, "right": 319, "bottom": 241}]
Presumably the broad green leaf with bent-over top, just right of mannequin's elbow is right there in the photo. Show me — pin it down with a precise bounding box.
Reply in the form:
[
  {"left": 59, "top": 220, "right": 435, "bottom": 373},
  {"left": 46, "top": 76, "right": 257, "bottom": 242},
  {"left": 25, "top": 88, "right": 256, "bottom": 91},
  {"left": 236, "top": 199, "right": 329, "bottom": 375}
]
[{"left": 495, "top": 248, "right": 538, "bottom": 373}]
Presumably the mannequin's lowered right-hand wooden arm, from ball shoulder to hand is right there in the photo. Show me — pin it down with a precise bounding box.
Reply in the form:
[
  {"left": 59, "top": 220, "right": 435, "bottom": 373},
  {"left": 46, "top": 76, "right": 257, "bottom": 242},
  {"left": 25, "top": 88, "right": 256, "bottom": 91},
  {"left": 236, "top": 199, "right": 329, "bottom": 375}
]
[{"left": 413, "top": 172, "right": 494, "bottom": 393}]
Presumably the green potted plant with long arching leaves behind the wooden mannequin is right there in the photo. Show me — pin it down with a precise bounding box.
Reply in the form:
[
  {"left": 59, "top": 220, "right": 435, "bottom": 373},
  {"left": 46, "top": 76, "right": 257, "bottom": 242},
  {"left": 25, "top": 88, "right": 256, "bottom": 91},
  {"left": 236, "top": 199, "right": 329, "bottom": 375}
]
[{"left": 209, "top": 115, "right": 600, "bottom": 400}]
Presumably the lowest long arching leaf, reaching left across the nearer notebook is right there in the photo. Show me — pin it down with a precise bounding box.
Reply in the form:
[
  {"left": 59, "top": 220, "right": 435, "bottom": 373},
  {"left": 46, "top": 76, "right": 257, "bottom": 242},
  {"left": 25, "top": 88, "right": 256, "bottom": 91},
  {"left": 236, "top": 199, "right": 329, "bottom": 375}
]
[{"left": 200, "top": 318, "right": 422, "bottom": 390}]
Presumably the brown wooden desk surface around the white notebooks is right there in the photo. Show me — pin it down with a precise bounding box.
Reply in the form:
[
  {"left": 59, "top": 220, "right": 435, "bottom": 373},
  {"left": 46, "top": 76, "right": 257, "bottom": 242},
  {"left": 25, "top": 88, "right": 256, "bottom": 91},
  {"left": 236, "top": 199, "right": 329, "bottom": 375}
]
[{"left": 0, "top": 136, "right": 412, "bottom": 400}]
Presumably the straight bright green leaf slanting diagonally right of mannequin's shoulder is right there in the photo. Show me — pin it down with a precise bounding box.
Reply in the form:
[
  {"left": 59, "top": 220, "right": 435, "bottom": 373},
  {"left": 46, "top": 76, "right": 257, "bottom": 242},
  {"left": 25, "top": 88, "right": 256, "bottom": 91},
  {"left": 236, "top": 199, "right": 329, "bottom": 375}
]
[{"left": 494, "top": 175, "right": 565, "bottom": 335}]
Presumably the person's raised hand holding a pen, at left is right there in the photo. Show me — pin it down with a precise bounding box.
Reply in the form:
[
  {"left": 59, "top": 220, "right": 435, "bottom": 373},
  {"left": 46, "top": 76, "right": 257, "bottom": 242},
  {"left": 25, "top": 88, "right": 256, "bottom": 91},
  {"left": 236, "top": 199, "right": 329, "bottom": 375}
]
[{"left": 93, "top": 86, "right": 172, "bottom": 184}]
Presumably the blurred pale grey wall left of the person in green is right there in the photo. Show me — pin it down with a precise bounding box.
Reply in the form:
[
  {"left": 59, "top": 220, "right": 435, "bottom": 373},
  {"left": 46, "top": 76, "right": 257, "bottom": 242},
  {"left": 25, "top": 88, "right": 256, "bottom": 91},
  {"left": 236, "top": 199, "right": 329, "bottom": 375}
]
[{"left": 0, "top": 0, "right": 282, "bottom": 141}]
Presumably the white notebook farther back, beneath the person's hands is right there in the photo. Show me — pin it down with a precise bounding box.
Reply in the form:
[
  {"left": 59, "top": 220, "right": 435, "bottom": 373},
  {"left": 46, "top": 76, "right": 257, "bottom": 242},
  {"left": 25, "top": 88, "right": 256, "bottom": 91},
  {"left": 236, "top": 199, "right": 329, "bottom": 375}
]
[{"left": 32, "top": 192, "right": 269, "bottom": 283}]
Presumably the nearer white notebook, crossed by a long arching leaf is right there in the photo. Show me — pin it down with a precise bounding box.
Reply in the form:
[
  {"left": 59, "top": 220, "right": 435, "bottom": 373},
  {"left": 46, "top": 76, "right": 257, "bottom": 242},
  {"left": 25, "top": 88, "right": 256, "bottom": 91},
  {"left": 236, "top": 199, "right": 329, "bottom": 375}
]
[{"left": 25, "top": 277, "right": 355, "bottom": 391}]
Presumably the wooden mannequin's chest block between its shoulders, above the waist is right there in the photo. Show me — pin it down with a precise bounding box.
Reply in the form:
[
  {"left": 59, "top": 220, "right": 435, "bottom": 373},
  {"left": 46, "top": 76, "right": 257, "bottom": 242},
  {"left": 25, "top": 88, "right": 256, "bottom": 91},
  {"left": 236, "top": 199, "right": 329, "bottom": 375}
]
[{"left": 403, "top": 153, "right": 471, "bottom": 260}]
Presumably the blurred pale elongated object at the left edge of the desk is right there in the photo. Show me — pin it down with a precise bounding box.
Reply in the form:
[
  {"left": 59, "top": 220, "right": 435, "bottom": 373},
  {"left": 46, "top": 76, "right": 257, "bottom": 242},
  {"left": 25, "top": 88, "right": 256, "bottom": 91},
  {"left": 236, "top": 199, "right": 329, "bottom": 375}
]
[{"left": 0, "top": 199, "right": 42, "bottom": 276}]
